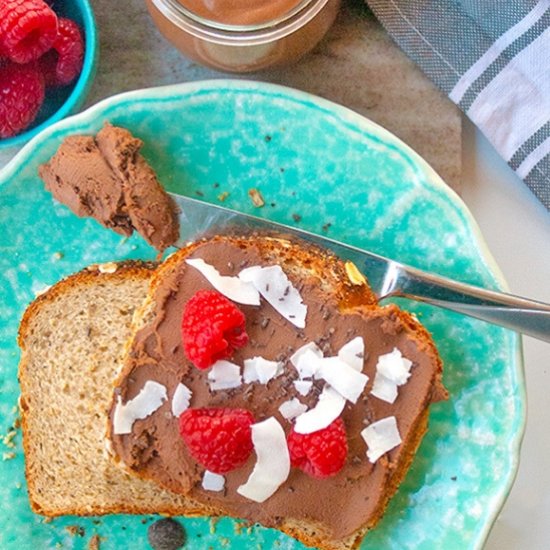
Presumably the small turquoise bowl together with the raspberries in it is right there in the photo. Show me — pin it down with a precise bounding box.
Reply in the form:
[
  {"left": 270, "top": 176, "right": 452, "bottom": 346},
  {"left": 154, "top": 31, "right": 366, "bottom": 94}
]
[{"left": 0, "top": 0, "right": 97, "bottom": 148}]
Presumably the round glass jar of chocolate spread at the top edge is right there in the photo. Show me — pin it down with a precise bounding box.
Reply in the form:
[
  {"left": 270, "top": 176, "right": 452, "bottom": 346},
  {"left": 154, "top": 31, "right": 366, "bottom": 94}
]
[{"left": 146, "top": 0, "right": 341, "bottom": 73}]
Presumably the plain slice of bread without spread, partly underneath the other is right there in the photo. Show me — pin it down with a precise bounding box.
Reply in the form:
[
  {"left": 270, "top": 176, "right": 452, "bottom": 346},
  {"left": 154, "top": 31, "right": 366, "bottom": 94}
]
[{"left": 19, "top": 263, "right": 209, "bottom": 516}]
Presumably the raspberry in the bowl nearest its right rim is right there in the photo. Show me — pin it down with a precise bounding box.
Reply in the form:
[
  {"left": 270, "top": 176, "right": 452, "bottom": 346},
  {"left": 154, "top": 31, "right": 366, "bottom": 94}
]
[{"left": 40, "top": 18, "right": 84, "bottom": 86}]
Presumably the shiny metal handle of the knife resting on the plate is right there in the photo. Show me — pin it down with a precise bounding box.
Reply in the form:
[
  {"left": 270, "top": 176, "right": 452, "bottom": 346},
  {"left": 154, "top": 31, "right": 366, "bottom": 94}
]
[{"left": 381, "top": 263, "right": 550, "bottom": 342}]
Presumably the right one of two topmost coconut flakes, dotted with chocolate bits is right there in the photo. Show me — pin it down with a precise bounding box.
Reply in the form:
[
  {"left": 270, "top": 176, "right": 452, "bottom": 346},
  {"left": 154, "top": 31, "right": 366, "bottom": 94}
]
[{"left": 239, "top": 265, "right": 307, "bottom": 328}]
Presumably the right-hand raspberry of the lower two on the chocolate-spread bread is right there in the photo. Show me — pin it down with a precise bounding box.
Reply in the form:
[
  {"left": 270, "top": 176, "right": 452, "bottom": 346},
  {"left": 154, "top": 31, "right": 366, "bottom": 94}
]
[{"left": 287, "top": 418, "right": 348, "bottom": 479}]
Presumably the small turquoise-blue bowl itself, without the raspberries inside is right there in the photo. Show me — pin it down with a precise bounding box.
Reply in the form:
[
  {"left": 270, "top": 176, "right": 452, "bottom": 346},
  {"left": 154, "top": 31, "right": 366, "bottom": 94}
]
[{"left": 0, "top": 0, "right": 98, "bottom": 149}]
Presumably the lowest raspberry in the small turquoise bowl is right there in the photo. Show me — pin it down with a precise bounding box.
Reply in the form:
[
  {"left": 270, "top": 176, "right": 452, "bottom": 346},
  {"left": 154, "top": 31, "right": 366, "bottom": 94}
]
[{"left": 0, "top": 59, "right": 44, "bottom": 138}]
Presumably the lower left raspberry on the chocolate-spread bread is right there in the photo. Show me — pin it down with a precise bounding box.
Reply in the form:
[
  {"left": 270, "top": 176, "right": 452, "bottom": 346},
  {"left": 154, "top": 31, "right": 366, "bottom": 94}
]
[{"left": 180, "top": 408, "right": 254, "bottom": 474}]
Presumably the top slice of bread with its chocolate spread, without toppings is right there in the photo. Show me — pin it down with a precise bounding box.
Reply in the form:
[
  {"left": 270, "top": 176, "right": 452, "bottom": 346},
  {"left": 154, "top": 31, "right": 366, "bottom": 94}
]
[{"left": 111, "top": 237, "right": 446, "bottom": 550}]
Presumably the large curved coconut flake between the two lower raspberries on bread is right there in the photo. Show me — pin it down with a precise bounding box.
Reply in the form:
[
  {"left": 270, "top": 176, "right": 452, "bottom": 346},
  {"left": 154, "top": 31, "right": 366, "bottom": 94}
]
[{"left": 237, "top": 416, "right": 290, "bottom": 502}]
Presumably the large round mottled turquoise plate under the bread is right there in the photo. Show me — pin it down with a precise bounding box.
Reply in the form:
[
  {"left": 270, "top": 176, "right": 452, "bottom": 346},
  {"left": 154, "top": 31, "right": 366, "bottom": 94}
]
[{"left": 0, "top": 80, "right": 525, "bottom": 550}]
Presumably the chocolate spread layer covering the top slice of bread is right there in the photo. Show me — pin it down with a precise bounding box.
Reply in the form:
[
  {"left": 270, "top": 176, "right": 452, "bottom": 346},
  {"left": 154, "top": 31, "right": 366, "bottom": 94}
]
[{"left": 110, "top": 240, "right": 446, "bottom": 538}]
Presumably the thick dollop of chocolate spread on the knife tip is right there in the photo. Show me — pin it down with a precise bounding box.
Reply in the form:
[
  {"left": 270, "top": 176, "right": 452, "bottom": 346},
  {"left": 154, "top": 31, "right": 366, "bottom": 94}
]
[{"left": 38, "top": 123, "right": 179, "bottom": 251}]
